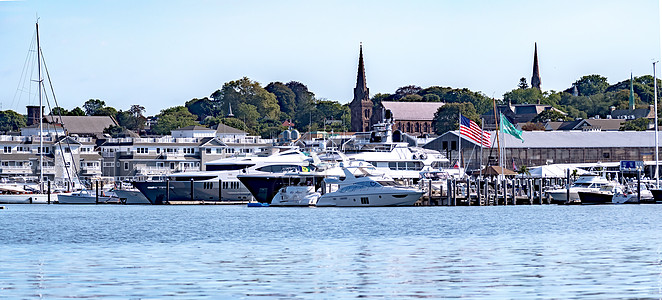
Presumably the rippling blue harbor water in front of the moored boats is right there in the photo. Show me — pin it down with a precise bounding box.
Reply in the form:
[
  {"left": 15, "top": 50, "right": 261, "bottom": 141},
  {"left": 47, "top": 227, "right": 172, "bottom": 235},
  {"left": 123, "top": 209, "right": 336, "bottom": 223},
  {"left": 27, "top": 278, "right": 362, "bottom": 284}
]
[{"left": 0, "top": 205, "right": 662, "bottom": 299}]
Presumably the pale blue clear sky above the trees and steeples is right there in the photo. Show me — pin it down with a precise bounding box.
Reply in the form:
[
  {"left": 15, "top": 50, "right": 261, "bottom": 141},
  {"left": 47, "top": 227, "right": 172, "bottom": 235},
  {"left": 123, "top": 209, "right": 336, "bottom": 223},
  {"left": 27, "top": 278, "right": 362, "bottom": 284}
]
[{"left": 0, "top": 0, "right": 660, "bottom": 115}]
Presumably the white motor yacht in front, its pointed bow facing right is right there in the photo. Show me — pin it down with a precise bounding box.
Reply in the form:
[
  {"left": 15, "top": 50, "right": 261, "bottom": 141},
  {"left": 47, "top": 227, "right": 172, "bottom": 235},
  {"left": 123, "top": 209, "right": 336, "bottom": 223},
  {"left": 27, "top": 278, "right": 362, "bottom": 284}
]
[{"left": 317, "top": 167, "right": 423, "bottom": 207}]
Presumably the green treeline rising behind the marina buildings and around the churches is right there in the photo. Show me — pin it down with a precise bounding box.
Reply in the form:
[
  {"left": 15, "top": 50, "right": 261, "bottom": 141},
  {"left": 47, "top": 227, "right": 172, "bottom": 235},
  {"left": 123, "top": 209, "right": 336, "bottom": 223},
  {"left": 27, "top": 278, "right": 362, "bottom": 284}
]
[{"left": 0, "top": 75, "right": 662, "bottom": 138}]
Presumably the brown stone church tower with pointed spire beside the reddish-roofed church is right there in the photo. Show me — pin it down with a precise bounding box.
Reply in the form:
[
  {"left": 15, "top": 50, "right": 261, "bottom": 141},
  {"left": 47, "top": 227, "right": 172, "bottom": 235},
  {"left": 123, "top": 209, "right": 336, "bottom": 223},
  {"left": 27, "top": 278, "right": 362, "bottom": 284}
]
[{"left": 349, "top": 44, "right": 372, "bottom": 132}]
